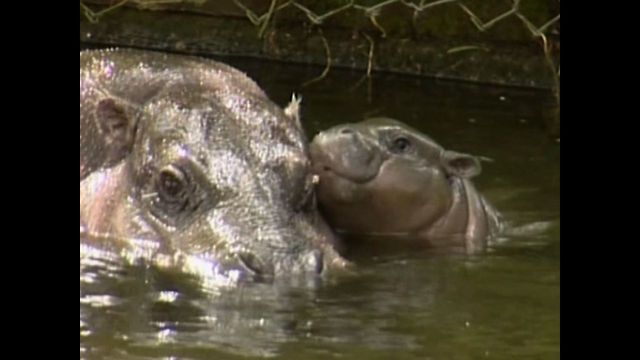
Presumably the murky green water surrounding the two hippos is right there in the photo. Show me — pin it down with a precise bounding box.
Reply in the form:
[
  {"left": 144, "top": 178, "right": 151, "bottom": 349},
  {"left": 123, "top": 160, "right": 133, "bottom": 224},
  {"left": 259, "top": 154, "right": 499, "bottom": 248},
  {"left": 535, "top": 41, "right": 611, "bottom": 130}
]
[{"left": 80, "top": 54, "right": 560, "bottom": 360}]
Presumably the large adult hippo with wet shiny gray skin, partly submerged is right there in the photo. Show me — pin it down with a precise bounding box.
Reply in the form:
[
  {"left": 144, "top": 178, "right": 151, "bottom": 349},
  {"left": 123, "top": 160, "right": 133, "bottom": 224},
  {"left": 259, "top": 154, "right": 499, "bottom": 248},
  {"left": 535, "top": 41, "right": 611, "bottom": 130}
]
[{"left": 80, "top": 50, "right": 346, "bottom": 277}]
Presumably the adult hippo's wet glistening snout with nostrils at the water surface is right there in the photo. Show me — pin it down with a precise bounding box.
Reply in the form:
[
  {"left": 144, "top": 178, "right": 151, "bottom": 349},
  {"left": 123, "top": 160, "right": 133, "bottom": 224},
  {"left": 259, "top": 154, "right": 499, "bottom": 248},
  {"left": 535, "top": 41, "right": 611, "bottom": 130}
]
[{"left": 185, "top": 199, "right": 332, "bottom": 278}]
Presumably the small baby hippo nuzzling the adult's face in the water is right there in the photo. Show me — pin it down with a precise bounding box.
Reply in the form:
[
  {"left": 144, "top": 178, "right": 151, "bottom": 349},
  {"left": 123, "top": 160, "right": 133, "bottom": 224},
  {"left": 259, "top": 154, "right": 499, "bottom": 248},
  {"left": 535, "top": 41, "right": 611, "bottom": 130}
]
[{"left": 310, "top": 118, "right": 501, "bottom": 253}]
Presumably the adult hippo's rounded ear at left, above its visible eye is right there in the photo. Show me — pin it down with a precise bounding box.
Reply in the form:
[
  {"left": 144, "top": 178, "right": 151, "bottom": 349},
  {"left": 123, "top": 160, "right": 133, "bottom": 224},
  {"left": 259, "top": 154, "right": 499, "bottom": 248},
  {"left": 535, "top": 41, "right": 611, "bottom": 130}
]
[{"left": 95, "top": 98, "right": 136, "bottom": 163}]
